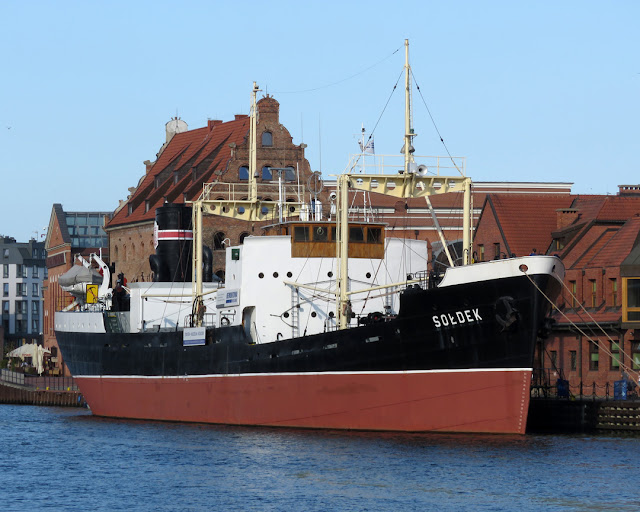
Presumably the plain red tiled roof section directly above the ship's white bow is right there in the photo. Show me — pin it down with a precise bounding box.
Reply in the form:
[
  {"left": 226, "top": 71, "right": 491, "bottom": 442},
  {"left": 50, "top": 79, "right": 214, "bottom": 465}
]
[{"left": 483, "top": 194, "right": 572, "bottom": 256}]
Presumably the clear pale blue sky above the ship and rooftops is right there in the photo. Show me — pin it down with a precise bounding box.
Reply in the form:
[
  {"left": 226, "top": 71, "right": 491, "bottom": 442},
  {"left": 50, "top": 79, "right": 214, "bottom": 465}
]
[{"left": 0, "top": 0, "right": 640, "bottom": 241}]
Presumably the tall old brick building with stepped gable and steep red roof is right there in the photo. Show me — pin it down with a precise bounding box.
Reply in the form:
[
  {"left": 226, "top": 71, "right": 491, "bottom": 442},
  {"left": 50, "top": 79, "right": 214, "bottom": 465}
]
[{"left": 106, "top": 95, "right": 318, "bottom": 281}]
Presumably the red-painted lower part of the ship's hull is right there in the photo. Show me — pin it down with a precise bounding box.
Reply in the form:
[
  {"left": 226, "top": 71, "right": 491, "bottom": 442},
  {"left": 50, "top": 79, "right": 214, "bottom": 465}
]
[{"left": 76, "top": 368, "right": 531, "bottom": 434}]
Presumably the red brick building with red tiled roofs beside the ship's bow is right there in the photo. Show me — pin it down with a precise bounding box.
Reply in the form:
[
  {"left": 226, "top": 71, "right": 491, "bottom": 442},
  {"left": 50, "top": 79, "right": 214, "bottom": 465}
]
[{"left": 474, "top": 186, "right": 640, "bottom": 396}]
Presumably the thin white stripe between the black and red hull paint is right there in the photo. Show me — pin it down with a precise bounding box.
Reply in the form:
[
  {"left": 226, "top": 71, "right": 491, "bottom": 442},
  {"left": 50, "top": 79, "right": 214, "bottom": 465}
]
[{"left": 75, "top": 368, "right": 533, "bottom": 380}]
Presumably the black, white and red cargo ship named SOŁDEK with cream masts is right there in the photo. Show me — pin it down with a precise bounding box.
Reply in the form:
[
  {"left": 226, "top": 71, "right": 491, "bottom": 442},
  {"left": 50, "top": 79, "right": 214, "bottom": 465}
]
[{"left": 55, "top": 41, "right": 564, "bottom": 434}]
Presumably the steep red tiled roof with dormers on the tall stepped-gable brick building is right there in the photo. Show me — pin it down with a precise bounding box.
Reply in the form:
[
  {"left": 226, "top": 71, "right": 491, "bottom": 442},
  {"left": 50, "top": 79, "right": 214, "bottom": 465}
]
[{"left": 107, "top": 116, "right": 249, "bottom": 228}]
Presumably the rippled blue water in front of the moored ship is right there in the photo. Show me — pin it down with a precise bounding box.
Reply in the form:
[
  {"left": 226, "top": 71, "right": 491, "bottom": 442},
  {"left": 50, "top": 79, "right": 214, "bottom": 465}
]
[{"left": 0, "top": 405, "right": 640, "bottom": 512}]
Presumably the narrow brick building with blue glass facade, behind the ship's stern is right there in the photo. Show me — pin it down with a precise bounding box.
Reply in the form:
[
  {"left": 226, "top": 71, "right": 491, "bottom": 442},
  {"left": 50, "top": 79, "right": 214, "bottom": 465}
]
[{"left": 42, "top": 204, "right": 111, "bottom": 375}]
